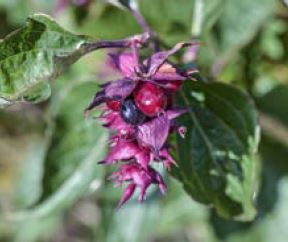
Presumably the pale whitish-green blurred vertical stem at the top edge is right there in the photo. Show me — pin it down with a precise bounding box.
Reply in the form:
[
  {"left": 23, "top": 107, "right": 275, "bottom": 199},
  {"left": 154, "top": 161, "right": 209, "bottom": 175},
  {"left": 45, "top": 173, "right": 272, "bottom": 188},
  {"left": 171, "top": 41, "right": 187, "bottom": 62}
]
[{"left": 191, "top": 0, "right": 204, "bottom": 38}]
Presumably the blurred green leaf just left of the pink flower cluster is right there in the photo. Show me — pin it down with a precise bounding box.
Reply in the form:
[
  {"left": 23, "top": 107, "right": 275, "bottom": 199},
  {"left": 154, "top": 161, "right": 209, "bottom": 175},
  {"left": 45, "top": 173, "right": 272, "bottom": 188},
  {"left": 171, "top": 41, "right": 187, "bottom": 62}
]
[{"left": 44, "top": 78, "right": 107, "bottom": 195}]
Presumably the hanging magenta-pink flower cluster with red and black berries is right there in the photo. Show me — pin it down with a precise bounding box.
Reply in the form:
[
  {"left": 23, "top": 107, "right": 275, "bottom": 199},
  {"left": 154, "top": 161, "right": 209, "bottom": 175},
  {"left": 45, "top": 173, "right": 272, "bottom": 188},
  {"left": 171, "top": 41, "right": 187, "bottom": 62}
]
[{"left": 86, "top": 38, "right": 196, "bottom": 207}]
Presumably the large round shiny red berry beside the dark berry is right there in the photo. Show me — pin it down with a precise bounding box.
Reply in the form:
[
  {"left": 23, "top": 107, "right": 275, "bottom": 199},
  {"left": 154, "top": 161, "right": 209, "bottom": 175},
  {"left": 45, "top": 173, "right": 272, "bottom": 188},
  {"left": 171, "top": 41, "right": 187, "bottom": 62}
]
[{"left": 134, "top": 83, "right": 167, "bottom": 117}]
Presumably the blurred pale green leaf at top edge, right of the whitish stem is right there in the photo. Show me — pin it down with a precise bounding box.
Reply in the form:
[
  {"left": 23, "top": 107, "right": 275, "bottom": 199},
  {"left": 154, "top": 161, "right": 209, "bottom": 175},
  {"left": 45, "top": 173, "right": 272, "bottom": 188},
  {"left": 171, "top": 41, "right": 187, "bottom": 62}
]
[{"left": 219, "top": 0, "right": 276, "bottom": 58}]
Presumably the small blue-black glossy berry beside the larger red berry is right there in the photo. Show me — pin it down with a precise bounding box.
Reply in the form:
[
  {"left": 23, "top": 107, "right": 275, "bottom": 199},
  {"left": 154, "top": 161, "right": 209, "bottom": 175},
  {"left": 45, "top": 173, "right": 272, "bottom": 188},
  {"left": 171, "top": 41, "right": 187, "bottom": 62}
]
[{"left": 120, "top": 99, "right": 146, "bottom": 125}]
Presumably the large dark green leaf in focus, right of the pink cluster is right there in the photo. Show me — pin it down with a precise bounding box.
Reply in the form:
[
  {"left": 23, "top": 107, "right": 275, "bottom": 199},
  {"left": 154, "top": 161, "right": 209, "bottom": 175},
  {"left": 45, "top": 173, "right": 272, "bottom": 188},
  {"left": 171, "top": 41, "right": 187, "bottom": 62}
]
[{"left": 174, "top": 81, "right": 259, "bottom": 220}]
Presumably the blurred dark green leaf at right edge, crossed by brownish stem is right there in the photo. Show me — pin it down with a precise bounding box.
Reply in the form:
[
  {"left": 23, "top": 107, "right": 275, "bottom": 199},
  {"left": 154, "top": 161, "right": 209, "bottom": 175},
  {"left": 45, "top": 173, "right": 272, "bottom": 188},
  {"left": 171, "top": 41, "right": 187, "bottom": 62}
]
[{"left": 257, "top": 85, "right": 288, "bottom": 176}]
